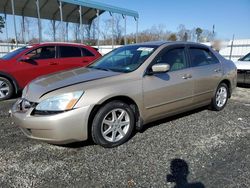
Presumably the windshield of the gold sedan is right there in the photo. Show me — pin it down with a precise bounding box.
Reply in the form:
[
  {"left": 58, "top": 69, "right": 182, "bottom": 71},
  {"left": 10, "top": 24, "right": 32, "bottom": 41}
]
[{"left": 88, "top": 45, "right": 157, "bottom": 72}]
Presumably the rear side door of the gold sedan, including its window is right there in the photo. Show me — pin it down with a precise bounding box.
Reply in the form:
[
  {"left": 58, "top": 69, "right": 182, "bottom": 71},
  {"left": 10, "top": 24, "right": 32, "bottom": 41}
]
[{"left": 188, "top": 45, "right": 222, "bottom": 104}]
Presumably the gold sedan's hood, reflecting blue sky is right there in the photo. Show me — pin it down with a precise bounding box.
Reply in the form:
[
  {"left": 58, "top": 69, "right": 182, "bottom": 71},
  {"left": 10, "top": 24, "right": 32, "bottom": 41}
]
[{"left": 22, "top": 68, "right": 122, "bottom": 102}]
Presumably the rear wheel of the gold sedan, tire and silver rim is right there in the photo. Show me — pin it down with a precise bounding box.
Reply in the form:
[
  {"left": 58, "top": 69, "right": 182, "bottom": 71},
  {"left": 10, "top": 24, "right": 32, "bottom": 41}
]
[{"left": 210, "top": 83, "right": 229, "bottom": 111}]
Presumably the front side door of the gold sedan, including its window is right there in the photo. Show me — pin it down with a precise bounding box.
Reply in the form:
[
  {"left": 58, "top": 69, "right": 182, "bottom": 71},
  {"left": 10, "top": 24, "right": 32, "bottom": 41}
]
[{"left": 143, "top": 45, "right": 194, "bottom": 119}]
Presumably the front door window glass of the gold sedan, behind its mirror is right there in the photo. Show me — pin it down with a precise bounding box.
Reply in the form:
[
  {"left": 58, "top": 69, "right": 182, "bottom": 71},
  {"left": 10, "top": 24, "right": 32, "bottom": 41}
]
[{"left": 156, "top": 48, "right": 188, "bottom": 71}]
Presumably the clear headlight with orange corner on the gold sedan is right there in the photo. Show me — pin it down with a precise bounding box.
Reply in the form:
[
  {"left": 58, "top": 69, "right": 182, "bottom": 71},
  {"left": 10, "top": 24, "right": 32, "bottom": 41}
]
[{"left": 36, "top": 91, "right": 84, "bottom": 111}]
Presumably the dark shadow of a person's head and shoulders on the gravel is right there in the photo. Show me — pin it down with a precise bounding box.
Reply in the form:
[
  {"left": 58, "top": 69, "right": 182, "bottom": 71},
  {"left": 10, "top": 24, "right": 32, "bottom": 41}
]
[{"left": 166, "top": 158, "right": 205, "bottom": 188}]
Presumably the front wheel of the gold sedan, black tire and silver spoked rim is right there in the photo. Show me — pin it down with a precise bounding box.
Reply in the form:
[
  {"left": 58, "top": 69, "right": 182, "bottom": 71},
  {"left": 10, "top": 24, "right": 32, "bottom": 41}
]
[{"left": 91, "top": 101, "right": 135, "bottom": 148}]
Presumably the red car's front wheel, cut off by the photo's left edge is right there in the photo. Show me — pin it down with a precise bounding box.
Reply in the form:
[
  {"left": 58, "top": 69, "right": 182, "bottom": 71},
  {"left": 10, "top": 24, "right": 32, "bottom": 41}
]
[{"left": 0, "top": 77, "right": 14, "bottom": 101}]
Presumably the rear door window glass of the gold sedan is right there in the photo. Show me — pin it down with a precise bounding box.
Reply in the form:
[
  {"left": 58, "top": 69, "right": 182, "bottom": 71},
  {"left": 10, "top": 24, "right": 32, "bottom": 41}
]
[{"left": 189, "top": 48, "right": 219, "bottom": 67}]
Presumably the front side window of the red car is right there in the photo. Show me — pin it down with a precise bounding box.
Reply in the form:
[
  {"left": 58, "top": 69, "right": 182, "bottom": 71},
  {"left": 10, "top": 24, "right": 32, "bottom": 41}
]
[{"left": 26, "top": 46, "right": 55, "bottom": 59}]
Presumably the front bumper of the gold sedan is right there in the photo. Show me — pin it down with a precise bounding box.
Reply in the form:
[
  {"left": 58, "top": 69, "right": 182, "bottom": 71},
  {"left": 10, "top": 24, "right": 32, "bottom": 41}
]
[{"left": 10, "top": 101, "right": 91, "bottom": 144}]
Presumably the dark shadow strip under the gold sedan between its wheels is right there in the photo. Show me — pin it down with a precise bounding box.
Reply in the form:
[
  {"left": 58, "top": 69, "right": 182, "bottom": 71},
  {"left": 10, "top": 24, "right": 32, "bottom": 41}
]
[{"left": 139, "top": 106, "right": 208, "bottom": 136}]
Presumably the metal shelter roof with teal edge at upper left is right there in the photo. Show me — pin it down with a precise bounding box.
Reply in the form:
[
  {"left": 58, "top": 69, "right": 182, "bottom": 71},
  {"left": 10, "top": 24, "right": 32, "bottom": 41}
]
[{"left": 0, "top": 0, "right": 139, "bottom": 24}]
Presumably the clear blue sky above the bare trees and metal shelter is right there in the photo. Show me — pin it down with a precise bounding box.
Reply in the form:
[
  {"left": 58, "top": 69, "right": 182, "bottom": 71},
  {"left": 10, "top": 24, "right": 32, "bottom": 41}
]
[{"left": 0, "top": 0, "right": 250, "bottom": 40}]
